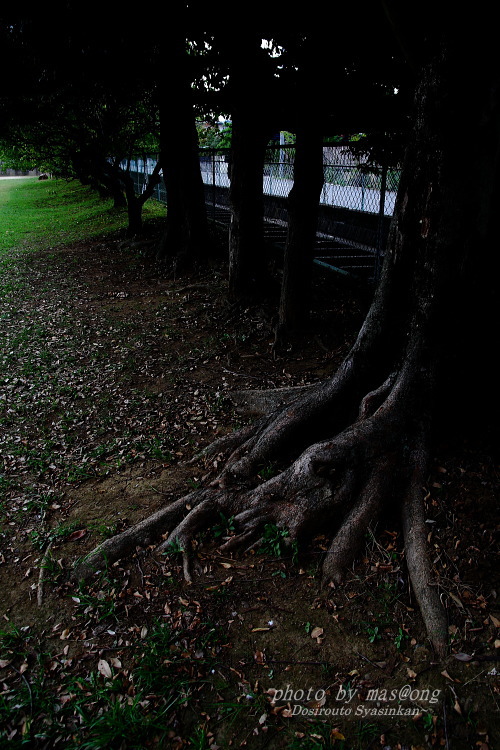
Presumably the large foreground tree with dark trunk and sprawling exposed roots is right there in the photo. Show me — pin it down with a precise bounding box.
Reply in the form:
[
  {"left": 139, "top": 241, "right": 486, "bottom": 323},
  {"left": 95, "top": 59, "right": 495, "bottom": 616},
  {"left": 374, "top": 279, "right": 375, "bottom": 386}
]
[{"left": 78, "top": 19, "right": 500, "bottom": 654}]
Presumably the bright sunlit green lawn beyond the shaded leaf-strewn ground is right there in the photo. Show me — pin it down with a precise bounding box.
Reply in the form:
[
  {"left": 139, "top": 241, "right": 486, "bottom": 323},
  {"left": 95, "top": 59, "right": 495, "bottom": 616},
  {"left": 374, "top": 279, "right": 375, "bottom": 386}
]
[{"left": 0, "top": 177, "right": 165, "bottom": 253}]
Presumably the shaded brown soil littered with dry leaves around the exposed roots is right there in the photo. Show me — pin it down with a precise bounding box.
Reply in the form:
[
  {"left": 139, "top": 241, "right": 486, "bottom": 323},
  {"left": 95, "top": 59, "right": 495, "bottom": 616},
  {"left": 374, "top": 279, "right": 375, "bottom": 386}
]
[{"left": 0, "top": 231, "right": 500, "bottom": 750}]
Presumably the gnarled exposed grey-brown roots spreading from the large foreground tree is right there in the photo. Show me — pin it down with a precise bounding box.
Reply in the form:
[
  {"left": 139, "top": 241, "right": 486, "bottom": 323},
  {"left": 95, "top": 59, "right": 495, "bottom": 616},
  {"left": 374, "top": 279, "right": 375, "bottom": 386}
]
[{"left": 75, "top": 367, "right": 446, "bottom": 655}]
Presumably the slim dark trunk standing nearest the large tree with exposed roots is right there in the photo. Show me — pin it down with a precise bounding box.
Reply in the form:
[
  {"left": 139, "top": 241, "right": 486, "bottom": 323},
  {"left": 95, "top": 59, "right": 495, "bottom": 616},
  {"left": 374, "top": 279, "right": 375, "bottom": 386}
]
[{"left": 276, "top": 127, "right": 323, "bottom": 341}]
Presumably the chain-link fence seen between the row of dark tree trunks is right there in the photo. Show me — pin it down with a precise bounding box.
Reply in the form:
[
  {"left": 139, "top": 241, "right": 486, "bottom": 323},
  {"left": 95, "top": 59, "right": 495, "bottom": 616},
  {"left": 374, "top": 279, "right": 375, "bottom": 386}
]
[{"left": 122, "top": 144, "right": 401, "bottom": 278}]
